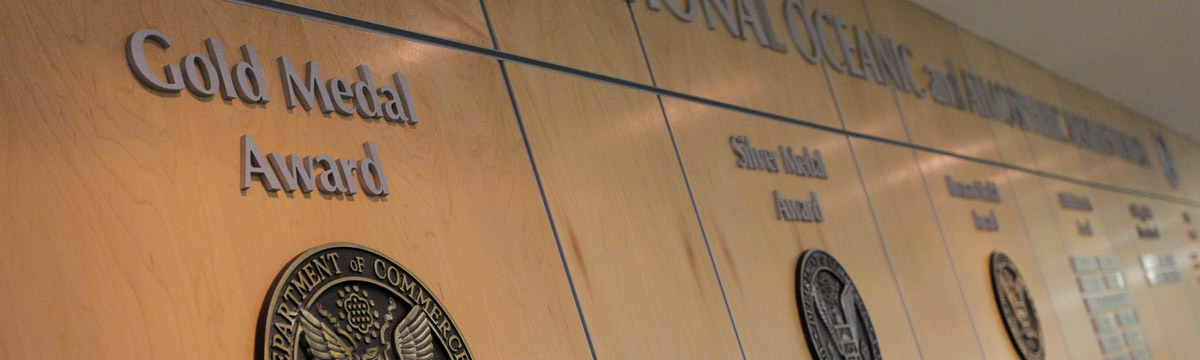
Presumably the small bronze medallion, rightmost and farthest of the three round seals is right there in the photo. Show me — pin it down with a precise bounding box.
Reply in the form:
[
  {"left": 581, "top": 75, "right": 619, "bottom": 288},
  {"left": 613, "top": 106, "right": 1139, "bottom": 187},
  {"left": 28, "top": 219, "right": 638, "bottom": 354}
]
[{"left": 991, "top": 251, "right": 1045, "bottom": 360}]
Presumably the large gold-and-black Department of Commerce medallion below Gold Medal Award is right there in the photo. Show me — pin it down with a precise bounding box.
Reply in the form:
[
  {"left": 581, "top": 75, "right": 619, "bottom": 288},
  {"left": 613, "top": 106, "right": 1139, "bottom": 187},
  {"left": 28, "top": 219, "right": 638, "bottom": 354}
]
[{"left": 258, "top": 242, "right": 474, "bottom": 360}]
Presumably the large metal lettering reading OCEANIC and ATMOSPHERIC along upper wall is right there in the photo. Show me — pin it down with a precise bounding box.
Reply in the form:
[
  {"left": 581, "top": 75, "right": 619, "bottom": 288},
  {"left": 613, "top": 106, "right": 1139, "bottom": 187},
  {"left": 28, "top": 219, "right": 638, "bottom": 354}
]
[{"left": 625, "top": 0, "right": 1152, "bottom": 165}]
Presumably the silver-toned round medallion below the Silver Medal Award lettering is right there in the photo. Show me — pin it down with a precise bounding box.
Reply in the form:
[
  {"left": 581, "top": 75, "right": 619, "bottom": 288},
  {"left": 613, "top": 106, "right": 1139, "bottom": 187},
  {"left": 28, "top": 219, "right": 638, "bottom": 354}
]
[{"left": 796, "top": 248, "right": 882, "bottom": 360}]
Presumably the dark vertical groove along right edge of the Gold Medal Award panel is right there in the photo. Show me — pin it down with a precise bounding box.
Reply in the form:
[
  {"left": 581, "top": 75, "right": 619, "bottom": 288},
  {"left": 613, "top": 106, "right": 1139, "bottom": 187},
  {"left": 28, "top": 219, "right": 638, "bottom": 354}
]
[{"left": 479, "top": 0, "right": 599, "bottom": 360}]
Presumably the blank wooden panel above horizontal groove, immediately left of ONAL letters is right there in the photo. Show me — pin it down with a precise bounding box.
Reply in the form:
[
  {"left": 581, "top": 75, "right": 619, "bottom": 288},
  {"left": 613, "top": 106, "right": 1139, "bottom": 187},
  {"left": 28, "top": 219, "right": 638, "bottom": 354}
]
[{"left": 485, "top": 0, "right": 650, "bottom": 84}]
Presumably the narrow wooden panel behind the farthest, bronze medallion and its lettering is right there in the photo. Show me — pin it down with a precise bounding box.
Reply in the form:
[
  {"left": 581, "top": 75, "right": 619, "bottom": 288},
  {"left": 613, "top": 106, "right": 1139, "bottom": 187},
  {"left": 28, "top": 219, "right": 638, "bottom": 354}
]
[{"left": 917, "top": 151, "right": 1070, "bottom": 359}]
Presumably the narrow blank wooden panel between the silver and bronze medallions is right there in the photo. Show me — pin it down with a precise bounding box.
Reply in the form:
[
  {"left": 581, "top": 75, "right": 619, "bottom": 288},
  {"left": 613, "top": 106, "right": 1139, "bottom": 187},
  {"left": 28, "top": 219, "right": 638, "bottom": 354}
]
[{"left": 851, "top": 139, "right": 994, "bottom": 360}]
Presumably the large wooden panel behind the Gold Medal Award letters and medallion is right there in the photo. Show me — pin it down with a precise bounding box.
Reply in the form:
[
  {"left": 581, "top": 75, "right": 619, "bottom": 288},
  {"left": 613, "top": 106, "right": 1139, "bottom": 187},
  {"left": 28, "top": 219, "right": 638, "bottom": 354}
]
[{"left": 0, "top": 1, "right": 588, "bottom": 359}]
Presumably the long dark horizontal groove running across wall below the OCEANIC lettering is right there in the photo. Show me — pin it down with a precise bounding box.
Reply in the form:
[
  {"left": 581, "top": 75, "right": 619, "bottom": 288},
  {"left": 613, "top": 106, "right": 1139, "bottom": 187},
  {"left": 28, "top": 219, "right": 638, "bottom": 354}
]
[{"left": 226, "top": 0, "right": 1200, "bottom": 208}]
